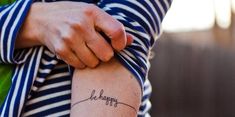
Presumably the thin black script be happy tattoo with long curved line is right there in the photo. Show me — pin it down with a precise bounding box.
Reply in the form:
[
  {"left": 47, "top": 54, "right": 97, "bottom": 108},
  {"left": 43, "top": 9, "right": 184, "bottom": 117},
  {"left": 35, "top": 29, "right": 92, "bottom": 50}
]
[{"left": 72, "top": 89, "right": 137, "bottom": 113}]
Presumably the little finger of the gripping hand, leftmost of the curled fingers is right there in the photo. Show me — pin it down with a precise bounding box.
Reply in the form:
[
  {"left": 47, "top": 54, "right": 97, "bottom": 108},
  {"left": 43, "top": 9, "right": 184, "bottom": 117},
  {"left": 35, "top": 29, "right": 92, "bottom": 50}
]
[{"left": 55, "top": 43, "right": 85, "bottom": 69}]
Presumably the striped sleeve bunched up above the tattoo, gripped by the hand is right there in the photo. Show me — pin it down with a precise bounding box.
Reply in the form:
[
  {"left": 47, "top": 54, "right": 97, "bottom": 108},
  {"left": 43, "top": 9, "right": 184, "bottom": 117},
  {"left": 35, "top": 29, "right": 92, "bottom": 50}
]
[{"left": 98, "top": 0, "right": 172, "bottom": 89}]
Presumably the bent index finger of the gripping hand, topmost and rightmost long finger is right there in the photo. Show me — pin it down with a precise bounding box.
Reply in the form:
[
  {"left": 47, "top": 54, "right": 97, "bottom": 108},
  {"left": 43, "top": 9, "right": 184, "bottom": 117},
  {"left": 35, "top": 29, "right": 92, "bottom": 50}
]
[{"left": 95, "top": 10, "right": 127, "bottom": 51}]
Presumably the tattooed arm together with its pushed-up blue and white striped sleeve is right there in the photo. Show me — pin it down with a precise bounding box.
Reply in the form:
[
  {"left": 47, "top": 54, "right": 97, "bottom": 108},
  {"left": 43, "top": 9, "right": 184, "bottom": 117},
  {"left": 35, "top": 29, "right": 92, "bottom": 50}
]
[{"left": 71, "top": 0, "right": 171, "bottom": 117}]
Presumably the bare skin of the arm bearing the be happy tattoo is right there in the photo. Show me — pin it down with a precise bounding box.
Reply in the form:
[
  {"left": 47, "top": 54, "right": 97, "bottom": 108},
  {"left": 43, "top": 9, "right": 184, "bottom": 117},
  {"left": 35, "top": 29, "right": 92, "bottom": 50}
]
[{"left": 71, "top": 59, "right": 141, "bottom": 117}]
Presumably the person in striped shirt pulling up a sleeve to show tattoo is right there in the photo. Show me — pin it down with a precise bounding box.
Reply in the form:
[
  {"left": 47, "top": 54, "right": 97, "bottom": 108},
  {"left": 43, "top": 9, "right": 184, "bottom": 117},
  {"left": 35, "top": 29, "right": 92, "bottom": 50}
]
[{"left": 0, "top": 0, "right": 171, "bottom": 117}]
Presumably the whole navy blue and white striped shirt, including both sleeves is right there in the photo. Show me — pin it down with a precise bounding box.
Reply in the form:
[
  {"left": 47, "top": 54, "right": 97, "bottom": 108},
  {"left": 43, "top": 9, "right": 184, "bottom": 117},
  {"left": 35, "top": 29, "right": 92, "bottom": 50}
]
[{"left": 0, "top": 0, "right": 171, "bottom": 117}]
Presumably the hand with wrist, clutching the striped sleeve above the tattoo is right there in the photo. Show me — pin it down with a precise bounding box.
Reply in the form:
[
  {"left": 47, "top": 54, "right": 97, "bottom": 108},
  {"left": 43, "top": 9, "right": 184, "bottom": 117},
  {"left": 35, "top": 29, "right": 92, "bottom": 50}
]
[{"left": 18, "top": 2, "right": 132, "bottom": 68}]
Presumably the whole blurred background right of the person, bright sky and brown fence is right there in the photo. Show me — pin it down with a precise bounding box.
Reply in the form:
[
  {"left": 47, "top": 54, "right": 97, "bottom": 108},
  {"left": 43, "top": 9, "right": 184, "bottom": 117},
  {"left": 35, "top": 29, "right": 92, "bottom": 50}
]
[{"left": 149, "top": 0, "right": 235, "bottom": 117}]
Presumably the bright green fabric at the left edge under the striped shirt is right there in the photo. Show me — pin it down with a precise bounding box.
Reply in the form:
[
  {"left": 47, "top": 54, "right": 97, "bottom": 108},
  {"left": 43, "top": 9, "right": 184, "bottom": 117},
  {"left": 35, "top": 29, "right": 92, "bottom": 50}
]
[{"left": 0, "top": 64, "right": 13, "bottom": 105}]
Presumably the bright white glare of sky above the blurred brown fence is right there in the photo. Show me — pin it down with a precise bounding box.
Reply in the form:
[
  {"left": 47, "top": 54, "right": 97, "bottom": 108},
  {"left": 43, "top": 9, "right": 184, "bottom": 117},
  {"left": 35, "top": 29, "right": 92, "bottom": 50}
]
[{"left": 163, "top": 0, "right": 216, "bottom": 32}]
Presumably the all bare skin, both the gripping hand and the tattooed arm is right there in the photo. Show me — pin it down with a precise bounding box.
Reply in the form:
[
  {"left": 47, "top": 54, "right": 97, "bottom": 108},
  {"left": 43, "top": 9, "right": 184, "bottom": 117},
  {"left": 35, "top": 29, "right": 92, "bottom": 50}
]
[{"left": 16, "top": 2, "right": 141, "bottom": 117}]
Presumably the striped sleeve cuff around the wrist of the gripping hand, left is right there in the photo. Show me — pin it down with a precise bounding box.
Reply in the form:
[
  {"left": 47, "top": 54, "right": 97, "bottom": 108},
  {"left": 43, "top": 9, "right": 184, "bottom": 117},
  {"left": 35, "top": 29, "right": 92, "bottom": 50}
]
[{"left": 0, "top": 0, "right": 32, "bottom": 64}]
